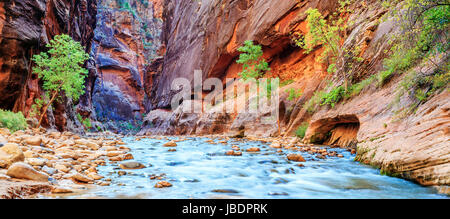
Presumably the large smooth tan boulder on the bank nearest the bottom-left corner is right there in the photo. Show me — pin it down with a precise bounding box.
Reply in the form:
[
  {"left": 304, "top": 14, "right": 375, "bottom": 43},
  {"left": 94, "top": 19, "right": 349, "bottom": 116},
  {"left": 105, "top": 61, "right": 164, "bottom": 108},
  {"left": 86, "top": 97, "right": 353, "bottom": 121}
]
[{"left": 6, "top": 162, "right": 48, "bottom": 182}]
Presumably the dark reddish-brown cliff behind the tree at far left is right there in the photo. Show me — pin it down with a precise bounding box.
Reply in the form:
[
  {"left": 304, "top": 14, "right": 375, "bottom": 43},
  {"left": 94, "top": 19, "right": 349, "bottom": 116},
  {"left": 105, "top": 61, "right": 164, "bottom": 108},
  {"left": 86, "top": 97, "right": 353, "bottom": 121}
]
[{"left": 0, "top": 0, "right": 97, "bottom": 130}]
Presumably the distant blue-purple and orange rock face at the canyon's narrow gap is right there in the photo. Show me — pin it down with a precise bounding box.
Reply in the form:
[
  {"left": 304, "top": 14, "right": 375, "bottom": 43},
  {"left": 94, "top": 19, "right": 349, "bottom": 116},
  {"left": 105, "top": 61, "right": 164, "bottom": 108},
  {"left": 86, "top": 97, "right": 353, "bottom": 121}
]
[{"left": 79, "top": 0, "right": 162, "bottom": 125}]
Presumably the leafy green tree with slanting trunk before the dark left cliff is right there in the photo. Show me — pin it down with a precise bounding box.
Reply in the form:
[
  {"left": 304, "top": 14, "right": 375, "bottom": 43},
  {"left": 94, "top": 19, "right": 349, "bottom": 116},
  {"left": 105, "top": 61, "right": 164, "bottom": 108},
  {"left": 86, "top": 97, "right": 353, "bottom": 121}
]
[{"left": 32, "top": 34, "right": 89, "bottom": 127}]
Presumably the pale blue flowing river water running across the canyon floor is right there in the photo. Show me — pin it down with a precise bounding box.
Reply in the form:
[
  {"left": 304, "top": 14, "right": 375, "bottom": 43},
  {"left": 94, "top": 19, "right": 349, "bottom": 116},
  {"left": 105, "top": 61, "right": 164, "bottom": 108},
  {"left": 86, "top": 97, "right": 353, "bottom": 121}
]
[{"left": 45, "top": 138, "right": 445, "bottom": 199}]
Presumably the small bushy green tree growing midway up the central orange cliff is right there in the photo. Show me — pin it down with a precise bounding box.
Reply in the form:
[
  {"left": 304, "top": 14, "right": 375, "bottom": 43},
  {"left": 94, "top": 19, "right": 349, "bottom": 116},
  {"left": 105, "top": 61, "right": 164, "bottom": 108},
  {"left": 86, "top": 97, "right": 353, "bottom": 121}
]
[{"left": 236, "top": 40, "right": 270, "bottom": 80}]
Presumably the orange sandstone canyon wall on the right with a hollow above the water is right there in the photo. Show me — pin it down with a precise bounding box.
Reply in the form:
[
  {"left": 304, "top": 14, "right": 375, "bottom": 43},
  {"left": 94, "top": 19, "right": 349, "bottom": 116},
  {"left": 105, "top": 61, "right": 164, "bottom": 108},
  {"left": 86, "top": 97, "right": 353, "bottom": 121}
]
[{"left": 140, "top": 0, "right": 450, "bottom": 190}]
